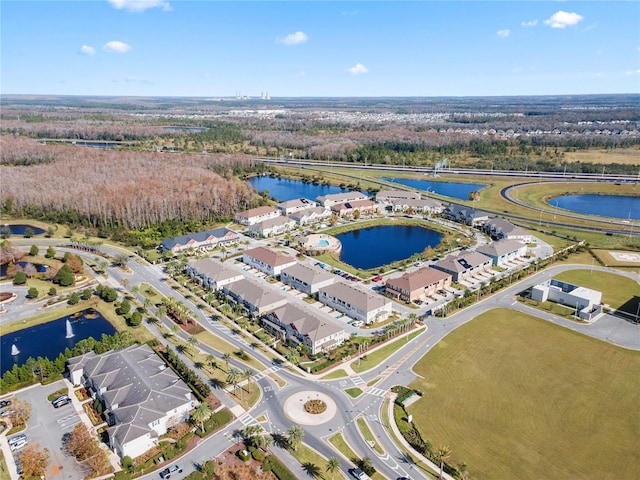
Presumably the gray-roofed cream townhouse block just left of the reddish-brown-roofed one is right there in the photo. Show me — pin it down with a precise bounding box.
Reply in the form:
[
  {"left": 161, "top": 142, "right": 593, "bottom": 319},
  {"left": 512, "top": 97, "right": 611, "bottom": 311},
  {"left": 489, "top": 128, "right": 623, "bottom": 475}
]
[{"left": 318, "top": 282, "right": 392, "bottom": 323}]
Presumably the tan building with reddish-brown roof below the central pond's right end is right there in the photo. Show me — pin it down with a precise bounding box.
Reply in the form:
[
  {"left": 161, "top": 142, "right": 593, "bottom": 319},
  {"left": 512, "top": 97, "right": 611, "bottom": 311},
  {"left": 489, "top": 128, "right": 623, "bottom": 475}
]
[{"left": 385, "top": 267, "right": 453, "bottom": 302}]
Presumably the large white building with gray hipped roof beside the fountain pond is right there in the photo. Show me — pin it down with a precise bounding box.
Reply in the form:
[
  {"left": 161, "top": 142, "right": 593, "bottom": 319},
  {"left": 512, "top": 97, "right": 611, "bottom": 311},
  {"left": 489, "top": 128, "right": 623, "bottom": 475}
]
[{"left": 68, "top": 344, "right": 195, "bottom": 458}]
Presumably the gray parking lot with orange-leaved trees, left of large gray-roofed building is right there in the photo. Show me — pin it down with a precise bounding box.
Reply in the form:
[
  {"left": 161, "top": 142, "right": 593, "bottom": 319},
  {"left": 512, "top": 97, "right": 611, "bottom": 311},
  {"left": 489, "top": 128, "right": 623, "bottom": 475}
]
[{"left": 0, "top": 380, "right": 89, "bottom": 480}]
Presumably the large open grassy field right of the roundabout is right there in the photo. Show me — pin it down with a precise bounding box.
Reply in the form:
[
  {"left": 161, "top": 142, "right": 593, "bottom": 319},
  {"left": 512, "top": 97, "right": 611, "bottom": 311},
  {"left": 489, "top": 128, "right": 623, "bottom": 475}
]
[{"left": 409, "top": 310, "right": 640, "bottom": 480}]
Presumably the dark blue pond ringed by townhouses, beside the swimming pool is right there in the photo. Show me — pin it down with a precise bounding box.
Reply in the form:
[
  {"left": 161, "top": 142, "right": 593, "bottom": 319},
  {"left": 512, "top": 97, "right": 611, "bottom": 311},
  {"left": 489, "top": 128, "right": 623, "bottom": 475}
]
[{"left": 335, "top": 225, "right": 442, "bottom": 270}]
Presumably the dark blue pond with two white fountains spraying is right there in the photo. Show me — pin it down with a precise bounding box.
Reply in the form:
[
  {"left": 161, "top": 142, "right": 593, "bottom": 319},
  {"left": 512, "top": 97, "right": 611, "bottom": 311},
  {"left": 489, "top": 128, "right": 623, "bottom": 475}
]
[{"left": 0, "top": 310, "right": 116, "bottom": 374}]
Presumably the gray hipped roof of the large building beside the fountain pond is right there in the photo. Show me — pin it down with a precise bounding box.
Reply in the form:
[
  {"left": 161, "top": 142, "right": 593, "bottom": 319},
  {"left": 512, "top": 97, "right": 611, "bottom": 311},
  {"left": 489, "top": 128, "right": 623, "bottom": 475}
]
[{"left": 69, "top": 344, "right": 191, "bottom": 444}]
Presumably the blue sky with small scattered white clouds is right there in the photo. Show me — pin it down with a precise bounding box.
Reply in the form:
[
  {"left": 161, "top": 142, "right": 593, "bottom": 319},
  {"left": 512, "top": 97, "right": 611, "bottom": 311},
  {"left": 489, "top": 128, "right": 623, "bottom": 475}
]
[{"left": 0, "top": 0, "right": 640, "bottom": 97}]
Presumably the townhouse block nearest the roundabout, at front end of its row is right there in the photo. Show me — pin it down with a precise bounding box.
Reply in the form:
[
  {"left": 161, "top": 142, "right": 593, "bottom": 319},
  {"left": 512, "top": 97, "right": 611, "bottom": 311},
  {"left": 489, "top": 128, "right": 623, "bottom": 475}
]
[{"left": 260, "top": 303, "right": 345, "bottom": 355}]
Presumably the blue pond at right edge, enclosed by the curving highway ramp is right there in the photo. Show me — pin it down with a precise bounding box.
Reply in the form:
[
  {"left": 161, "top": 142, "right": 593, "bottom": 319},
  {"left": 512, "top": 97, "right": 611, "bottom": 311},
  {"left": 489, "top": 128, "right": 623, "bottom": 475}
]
[{"left": 548, "top": 195, "right": 640, "bottom": 220}]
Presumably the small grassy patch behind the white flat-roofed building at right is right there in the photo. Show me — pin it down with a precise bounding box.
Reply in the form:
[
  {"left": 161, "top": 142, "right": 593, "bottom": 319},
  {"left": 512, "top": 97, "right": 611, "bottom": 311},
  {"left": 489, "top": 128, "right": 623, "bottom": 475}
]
[{"left": 554, "top": 270, "right": 640, "bottom": 314}]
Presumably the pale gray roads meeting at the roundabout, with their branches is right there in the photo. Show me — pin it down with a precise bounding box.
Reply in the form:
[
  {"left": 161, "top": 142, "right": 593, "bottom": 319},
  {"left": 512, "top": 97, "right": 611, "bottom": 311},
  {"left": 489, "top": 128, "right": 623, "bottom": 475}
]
[{"left": 0, "top": 240, "right": 640, "bottom": 479}]
